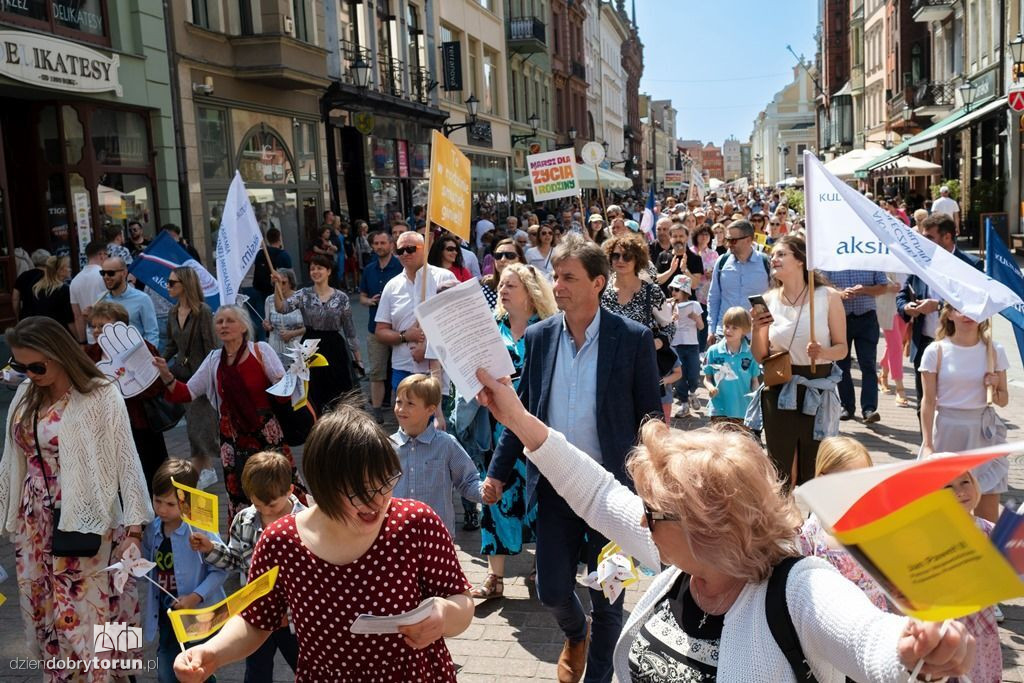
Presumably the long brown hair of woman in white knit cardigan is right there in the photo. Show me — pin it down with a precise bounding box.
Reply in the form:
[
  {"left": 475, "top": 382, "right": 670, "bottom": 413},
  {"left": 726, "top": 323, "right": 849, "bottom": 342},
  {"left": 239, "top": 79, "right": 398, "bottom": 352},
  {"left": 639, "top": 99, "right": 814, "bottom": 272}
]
[{"left": 5, "top": 315, "right": 106, "bottom": 438}]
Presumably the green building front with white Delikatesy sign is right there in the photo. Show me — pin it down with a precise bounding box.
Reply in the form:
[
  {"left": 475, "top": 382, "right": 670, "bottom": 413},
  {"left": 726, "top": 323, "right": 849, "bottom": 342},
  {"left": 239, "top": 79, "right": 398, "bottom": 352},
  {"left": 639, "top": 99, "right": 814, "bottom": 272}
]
[{"left": 0, "top": 0, "right": 182, "bottom": 324}]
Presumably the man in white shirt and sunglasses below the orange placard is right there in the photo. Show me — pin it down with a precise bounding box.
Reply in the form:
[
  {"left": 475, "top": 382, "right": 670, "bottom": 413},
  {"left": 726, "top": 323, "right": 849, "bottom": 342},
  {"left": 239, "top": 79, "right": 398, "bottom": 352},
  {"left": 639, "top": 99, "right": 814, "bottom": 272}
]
[{"left": 374, "top": 232, "right": 458, "bottom": 395}]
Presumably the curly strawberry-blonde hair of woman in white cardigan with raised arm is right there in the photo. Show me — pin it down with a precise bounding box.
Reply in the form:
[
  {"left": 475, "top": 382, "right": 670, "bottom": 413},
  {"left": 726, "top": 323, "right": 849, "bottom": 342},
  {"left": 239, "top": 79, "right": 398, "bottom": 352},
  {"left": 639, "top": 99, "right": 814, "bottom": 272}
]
[{"left": 626, "top": 420, "right": 800, "bottom": 583}]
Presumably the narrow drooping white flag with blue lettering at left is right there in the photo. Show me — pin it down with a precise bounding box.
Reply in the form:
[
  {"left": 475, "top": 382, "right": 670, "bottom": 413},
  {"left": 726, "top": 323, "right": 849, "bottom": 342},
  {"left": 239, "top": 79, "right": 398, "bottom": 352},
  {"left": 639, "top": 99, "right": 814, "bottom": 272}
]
[{"left": 216, "top": 171, "right": 263, "bottom": 305}]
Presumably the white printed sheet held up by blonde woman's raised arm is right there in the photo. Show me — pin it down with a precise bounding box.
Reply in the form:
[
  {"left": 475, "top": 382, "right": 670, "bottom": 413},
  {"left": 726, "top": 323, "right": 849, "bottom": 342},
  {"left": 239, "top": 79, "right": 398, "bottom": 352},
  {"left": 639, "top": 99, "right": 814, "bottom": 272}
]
[{"left": 416, "top": 280, "right": 515, "bottom": 398}]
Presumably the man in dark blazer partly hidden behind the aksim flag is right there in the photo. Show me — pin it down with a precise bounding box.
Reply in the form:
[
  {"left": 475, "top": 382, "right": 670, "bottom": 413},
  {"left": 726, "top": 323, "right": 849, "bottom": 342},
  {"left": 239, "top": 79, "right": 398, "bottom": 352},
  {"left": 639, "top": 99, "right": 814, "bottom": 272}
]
[{"left": 896, "top": 212, "right": 984, "bottom": 419}]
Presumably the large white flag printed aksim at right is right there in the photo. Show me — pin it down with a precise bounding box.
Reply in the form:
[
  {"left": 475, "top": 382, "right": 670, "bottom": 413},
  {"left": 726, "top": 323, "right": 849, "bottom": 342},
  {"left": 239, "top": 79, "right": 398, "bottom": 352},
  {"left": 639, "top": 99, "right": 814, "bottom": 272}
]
[{"left": 804, "top": 152, "right": 1022, "bottom": 321}]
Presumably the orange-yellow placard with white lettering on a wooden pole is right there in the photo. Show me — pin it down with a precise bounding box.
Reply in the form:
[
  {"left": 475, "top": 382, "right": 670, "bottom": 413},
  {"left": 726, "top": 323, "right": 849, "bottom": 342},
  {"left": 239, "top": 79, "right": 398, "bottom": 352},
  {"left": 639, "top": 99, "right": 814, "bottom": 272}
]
[{"left": 427, "top": 130, "right": 473, "bottom": 240}]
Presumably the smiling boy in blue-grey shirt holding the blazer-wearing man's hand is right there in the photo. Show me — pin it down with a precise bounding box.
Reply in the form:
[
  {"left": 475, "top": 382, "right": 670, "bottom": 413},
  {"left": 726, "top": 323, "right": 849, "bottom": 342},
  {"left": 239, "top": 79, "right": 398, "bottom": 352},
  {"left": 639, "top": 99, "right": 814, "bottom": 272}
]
[{"left": 391, "top": 375, "right": 483, "bottom": 533}]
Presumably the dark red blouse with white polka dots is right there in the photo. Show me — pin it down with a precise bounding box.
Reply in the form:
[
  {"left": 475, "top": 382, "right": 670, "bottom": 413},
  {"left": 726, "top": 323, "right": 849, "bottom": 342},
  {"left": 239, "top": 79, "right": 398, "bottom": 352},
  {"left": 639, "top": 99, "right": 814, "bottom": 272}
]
[{"left": 242, "top": 498, "right": 471, "bottom": 682}]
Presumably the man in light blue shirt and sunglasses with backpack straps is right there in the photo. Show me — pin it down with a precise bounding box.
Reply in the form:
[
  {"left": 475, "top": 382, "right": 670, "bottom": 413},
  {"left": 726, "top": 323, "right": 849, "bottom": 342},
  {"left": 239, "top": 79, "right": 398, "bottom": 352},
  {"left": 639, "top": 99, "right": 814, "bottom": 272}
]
[{"left": 708, "top": 220, "right": 771, "bottom": 345}]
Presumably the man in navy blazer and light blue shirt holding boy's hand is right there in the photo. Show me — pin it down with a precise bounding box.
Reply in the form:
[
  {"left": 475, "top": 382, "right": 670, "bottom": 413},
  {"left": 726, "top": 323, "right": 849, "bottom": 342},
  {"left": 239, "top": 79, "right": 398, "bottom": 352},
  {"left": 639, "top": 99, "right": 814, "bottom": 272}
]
[{"left": 484, "top": 236, "right": 662, "bottom": 683}]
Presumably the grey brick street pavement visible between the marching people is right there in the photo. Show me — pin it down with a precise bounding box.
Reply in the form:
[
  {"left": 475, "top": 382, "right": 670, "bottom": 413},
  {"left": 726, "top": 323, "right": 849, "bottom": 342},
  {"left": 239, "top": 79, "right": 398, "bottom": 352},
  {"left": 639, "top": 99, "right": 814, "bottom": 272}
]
[{"left": 0, "top": 326, "right": 1024, "bottom": 683}]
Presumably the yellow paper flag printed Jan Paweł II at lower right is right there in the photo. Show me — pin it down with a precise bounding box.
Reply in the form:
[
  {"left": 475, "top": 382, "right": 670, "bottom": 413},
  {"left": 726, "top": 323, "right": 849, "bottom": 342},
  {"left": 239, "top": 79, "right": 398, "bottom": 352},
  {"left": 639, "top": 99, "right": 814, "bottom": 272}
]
[{"left": 836, "top": 488, "right": 1024, "bottom": 622}]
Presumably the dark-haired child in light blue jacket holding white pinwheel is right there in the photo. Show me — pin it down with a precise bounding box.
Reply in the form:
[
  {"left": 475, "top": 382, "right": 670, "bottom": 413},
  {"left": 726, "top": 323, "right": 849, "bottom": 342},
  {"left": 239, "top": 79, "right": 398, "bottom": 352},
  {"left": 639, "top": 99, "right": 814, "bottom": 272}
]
[{"left": 142, "top": 459, "right": 227, "bottom": 683}]
